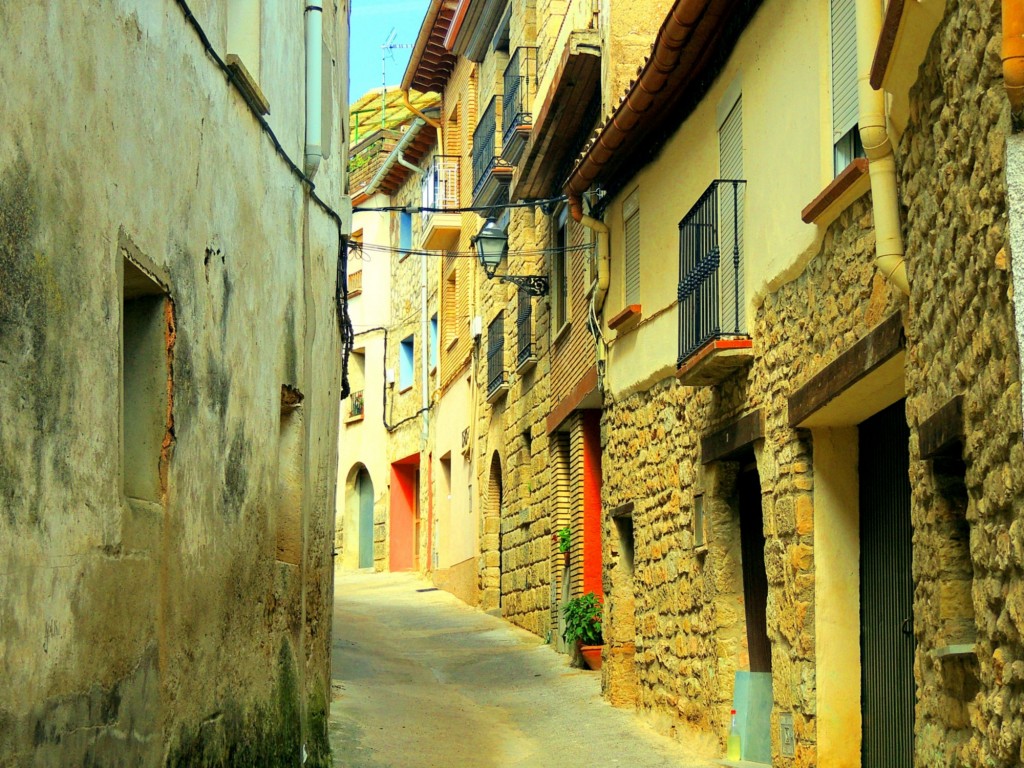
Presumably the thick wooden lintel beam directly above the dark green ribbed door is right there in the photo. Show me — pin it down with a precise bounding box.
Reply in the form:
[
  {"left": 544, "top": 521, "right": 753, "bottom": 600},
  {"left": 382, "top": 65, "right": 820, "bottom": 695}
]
[{"left": 790, "top": 312, "right": 906, "bottom": 427}]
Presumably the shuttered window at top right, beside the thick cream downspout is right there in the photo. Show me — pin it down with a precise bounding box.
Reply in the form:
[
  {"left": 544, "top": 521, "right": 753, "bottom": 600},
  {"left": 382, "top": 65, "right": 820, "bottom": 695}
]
[{"left": 830, "top": 0, "right": 864, "bottom": 176}]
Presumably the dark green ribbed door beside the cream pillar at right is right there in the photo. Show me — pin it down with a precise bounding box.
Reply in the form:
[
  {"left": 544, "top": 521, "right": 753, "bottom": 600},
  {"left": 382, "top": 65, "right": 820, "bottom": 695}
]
[{"left": 859, "top": 400, "right": 914, "bottom": 768}]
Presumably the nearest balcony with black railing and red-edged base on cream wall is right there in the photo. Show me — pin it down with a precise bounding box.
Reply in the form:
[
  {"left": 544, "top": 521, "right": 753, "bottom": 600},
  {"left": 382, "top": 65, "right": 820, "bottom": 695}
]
[{"left": 676, "top": 179, "right": 754, "bottom": 387}]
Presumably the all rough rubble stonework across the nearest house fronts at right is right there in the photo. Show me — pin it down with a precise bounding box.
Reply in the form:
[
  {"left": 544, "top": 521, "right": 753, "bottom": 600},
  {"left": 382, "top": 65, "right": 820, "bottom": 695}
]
[{"left": 602, "top": 2, "right": 1024, "bottom": 768}]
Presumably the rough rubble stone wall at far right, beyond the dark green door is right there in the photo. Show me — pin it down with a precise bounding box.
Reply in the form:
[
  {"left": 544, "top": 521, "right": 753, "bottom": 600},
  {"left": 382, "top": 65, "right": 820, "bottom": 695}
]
[{"left": 898, "top": 0, "right": 1024, "bottom": 766}]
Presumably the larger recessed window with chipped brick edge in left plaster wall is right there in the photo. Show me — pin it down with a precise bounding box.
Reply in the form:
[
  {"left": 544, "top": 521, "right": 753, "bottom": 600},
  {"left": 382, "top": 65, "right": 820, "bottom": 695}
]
[{"left": 121, "top": 256, "right": 170, "bottom": 503}]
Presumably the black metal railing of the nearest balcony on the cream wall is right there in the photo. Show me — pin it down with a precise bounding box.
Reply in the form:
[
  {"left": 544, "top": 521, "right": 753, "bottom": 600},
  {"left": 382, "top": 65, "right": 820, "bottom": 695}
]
[{"left": 676, "top": 179, "right": 746, "bottom": 368}]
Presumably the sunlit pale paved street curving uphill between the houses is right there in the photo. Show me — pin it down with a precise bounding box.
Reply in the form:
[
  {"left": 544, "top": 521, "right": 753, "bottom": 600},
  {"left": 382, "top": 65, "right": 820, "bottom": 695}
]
[{"left": 331, "top": 571, "right": 707, "bottom": 768}]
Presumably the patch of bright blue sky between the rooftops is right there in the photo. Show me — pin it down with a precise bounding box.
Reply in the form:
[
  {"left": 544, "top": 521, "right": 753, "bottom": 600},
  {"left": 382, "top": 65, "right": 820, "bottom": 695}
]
[{"left": 349, "top": 0, "right": 429, "bottom": 101}]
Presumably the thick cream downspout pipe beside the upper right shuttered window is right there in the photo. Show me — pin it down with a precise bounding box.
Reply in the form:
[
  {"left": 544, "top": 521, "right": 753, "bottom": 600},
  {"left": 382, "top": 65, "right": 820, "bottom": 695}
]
[{"left": 857, "top": 0, "right": 910, "bottom": 295}]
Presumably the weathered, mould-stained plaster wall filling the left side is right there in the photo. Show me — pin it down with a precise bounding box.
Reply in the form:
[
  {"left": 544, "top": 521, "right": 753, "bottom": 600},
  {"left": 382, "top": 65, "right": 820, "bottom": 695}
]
[{"left": 0, "top": 2, "right": 347, "bottom": 766}]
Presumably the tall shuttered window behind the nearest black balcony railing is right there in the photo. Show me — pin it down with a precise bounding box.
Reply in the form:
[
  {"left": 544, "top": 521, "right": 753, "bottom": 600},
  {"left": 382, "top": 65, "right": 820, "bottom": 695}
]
[{"left": 718, "top": 97, "right": 745, "bottom": 333}]
